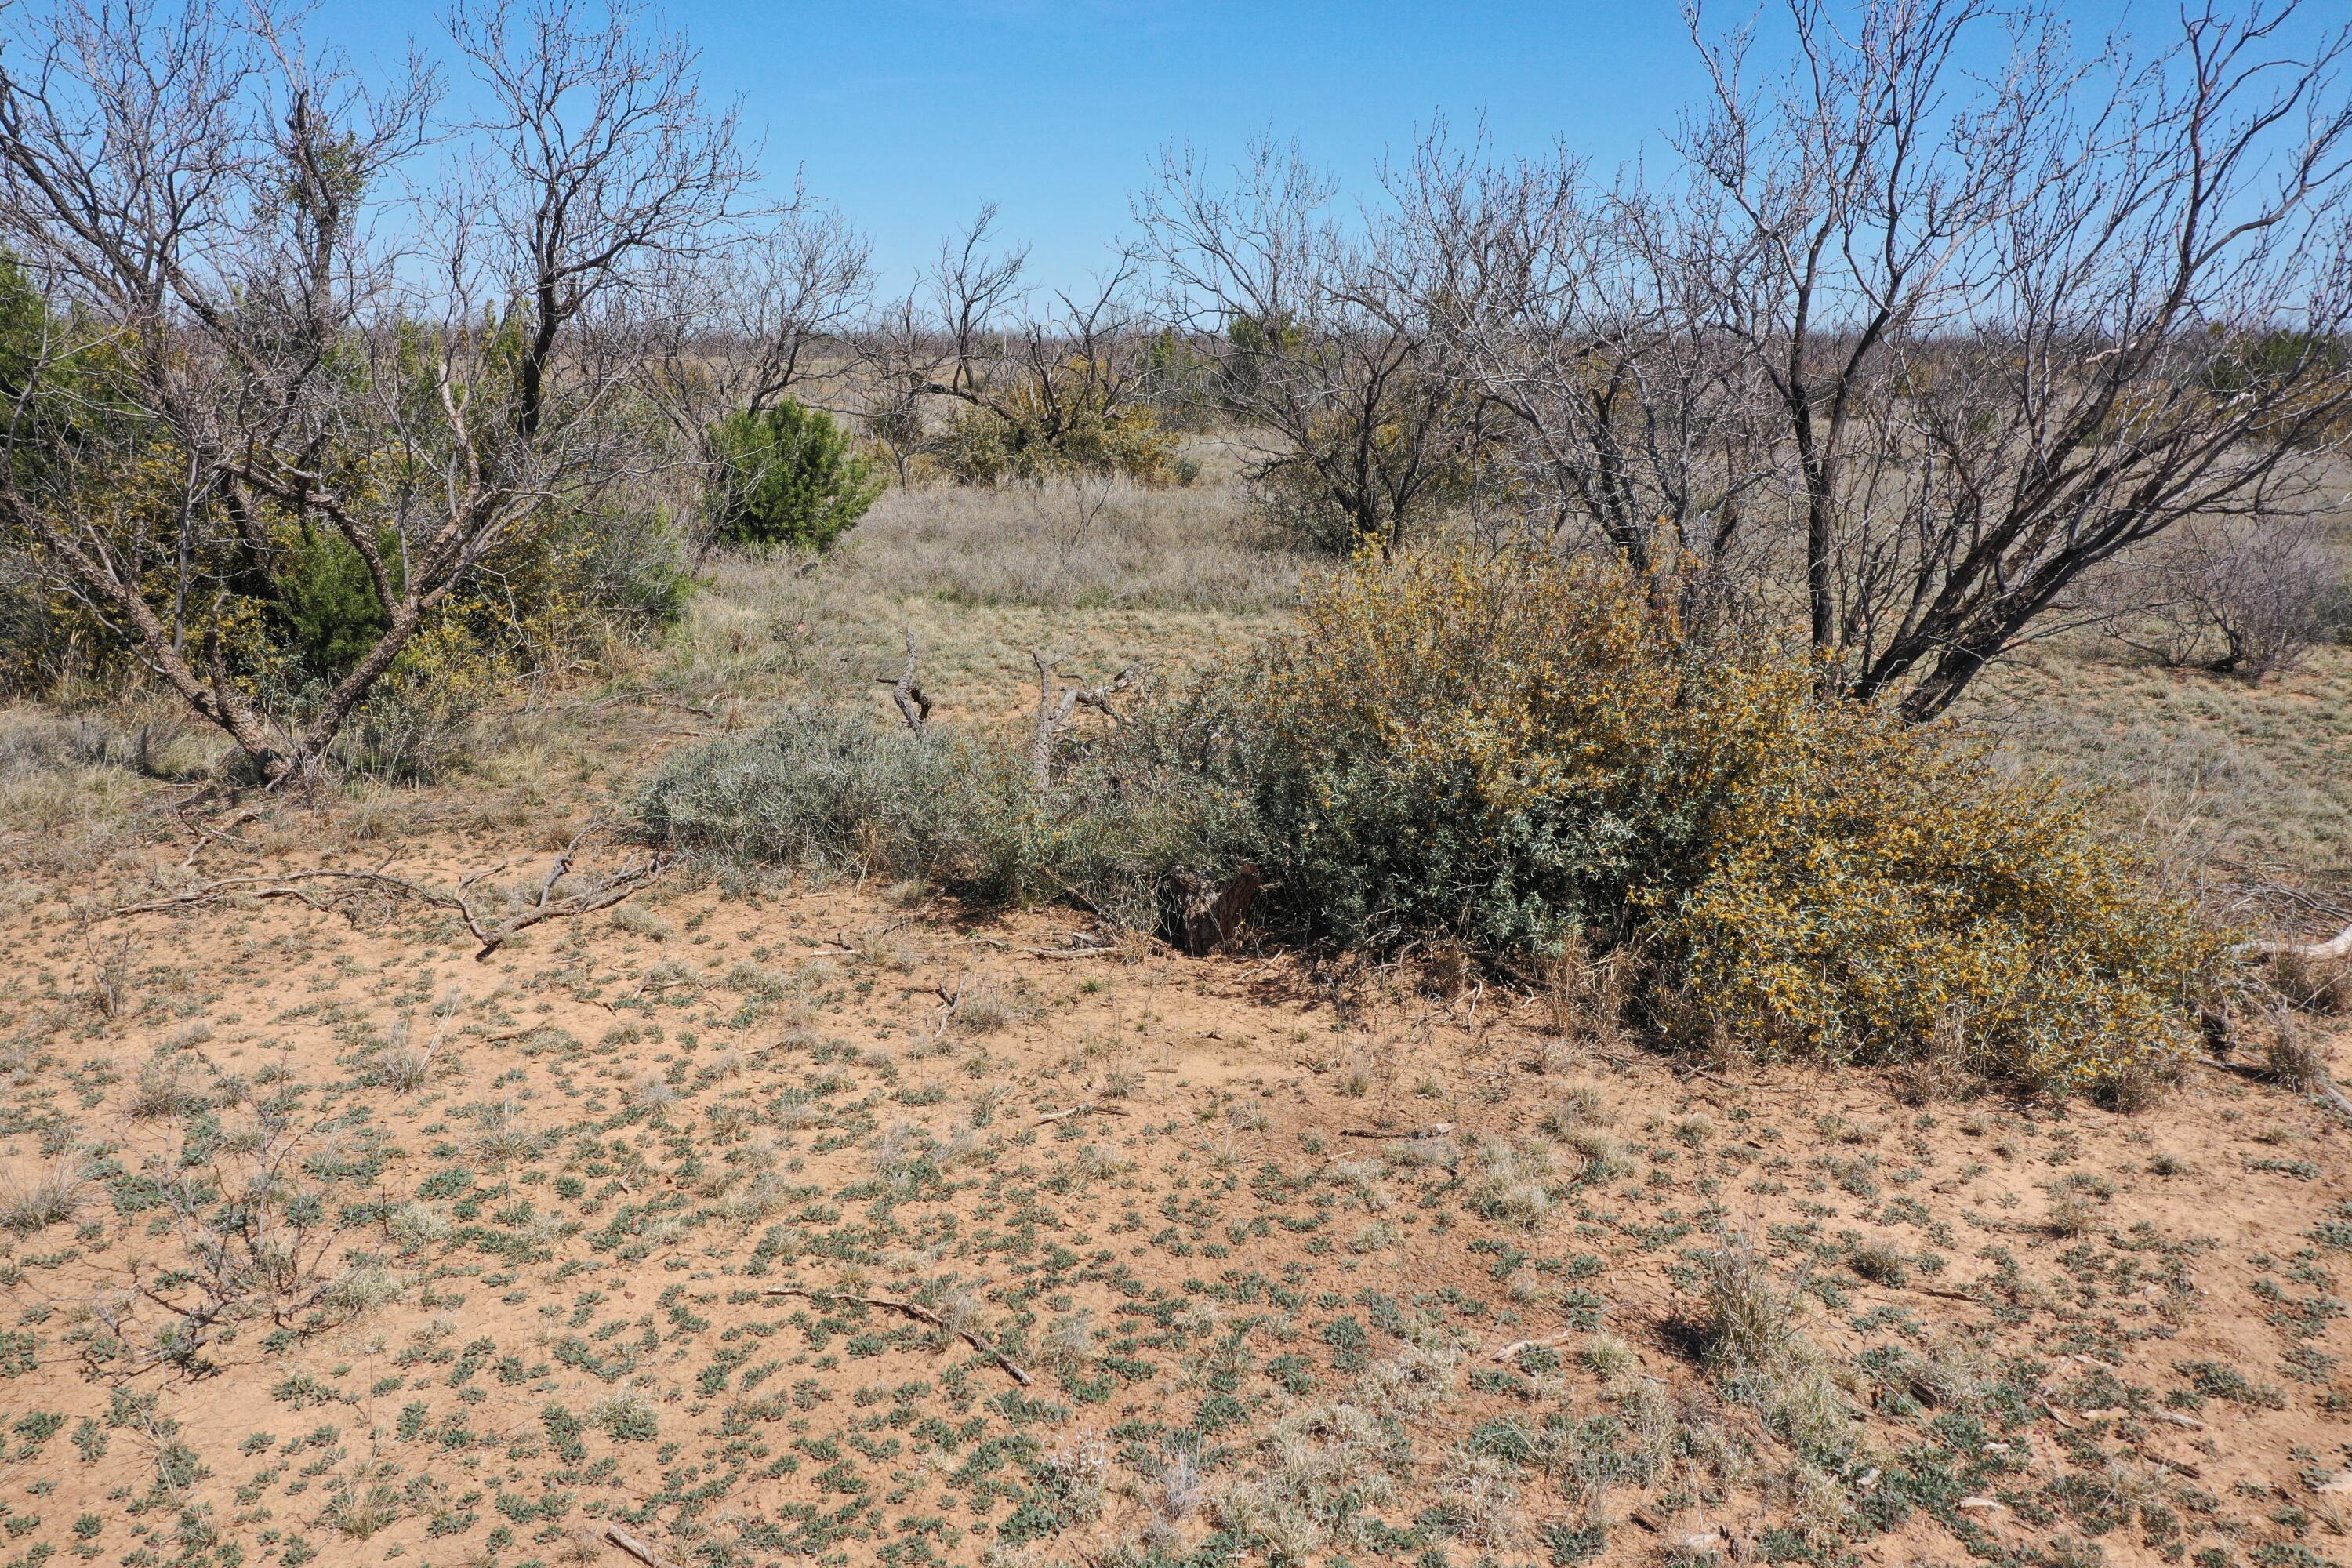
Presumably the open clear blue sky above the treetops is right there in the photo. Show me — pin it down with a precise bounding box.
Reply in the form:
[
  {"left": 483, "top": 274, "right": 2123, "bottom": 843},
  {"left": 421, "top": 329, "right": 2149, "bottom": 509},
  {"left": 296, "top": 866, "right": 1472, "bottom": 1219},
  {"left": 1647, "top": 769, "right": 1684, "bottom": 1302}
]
[{"left": 315, "top": 0, "right": 2336, "bottom": 285}]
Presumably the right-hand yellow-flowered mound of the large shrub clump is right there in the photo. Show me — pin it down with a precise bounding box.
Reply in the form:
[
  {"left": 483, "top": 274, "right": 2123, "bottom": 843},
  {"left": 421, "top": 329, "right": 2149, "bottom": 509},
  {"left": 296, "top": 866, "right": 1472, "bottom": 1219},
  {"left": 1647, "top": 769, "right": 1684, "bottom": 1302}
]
[{"left": 1637, "top": 703, "right": 2223, "bottom": 1091}]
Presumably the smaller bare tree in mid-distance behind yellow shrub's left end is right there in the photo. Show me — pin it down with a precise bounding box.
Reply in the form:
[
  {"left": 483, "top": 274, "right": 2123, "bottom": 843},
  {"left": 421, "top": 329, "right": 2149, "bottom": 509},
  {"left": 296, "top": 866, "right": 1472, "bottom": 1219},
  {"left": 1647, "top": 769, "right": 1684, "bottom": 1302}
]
[{"left": 1134, "top": 141, "right": 1479, "bottom": 548}]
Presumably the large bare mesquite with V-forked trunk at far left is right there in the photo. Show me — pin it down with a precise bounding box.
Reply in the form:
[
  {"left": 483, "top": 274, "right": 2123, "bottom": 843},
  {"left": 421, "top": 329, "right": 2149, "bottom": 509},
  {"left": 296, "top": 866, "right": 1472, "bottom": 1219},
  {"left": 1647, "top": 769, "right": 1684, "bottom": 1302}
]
[{"left": 0, "top": 0, "right": 748, "bottom": 785}]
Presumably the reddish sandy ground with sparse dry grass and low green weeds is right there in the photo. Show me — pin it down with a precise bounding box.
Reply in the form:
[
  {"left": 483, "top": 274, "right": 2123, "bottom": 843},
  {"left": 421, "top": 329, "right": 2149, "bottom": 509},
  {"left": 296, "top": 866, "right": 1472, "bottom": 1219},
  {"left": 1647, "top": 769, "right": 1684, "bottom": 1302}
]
[{"left": 0, "top": 489, "right": 2352, "bottom": 1568}]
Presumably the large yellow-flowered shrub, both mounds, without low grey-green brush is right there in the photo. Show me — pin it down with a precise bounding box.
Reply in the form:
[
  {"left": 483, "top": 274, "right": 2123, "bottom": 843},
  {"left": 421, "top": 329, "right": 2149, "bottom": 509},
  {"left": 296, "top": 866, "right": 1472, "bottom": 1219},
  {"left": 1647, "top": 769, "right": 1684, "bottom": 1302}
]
[{"left": 1195, "top": 550, "right": 2220, "bottom": 1088}]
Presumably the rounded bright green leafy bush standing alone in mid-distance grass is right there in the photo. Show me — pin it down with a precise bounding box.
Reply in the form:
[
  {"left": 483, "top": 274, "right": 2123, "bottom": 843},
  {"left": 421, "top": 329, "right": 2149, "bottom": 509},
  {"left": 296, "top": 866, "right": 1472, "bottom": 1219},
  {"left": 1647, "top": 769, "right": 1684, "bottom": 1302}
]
[{"left": 710, "top": 397, "right": 887, "bottom": 550}]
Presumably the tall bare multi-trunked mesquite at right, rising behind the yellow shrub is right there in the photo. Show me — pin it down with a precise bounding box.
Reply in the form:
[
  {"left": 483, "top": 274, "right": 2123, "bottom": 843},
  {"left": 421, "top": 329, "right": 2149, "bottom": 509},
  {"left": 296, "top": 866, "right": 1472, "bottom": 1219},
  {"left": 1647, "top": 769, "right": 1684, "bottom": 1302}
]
[{"left": 1682, "top": 0, "right": 2352, "bottom": 717}]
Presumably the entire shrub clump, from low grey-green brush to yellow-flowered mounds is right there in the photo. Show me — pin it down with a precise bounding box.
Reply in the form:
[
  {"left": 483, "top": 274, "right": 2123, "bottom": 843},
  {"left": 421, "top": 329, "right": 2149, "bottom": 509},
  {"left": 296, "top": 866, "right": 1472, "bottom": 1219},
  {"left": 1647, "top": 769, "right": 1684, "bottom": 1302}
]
[{"left": 644, "top": 550, "right": 2220, "bottom": 1093}]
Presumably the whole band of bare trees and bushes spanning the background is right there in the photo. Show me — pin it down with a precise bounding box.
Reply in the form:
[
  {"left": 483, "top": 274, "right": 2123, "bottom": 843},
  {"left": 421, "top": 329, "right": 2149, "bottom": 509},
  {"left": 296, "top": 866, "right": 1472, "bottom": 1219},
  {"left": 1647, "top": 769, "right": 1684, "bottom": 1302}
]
[{"left": 0, "top": 0, "right": 2352, "bottom": 785}]
